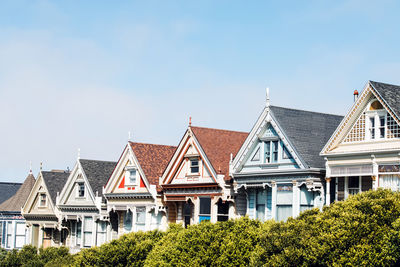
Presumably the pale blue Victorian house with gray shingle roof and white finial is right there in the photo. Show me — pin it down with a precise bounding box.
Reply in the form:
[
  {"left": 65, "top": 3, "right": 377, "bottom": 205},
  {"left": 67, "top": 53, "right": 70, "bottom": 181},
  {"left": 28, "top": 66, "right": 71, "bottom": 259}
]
[{"left": 231, "top": 91, "right": 343, "bottom": 221}]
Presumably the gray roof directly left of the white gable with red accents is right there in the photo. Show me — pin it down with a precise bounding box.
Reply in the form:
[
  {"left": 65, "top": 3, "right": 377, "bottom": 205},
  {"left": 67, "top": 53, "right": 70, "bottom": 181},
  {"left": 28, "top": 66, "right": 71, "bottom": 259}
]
[{"left": 79, "top": 159, "right": 117, "bottom": 199}]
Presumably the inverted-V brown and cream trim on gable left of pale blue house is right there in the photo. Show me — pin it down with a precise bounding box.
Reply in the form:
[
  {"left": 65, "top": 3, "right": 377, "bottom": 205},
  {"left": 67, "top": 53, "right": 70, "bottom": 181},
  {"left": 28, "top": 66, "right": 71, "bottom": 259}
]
[{"left": 161, "top": 127, "right": 218, "bottom": 185}]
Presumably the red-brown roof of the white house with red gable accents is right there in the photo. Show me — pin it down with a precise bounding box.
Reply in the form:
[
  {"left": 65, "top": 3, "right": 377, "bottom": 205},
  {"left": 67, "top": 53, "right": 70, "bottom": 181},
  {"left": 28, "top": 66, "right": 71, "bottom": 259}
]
[{"left": 129, "top": 142, "right": 176, "bottom": 189}]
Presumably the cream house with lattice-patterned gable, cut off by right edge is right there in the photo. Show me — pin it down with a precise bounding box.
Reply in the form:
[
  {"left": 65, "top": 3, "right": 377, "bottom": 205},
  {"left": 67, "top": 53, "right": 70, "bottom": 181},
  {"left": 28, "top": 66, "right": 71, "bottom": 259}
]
[{"left": 321, "top": 81, "right": 400, "bottom": 205}]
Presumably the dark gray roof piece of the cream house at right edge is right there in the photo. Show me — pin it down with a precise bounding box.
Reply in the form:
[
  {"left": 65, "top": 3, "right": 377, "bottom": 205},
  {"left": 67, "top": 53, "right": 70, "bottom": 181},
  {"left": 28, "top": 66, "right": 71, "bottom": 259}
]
[{"left": 369, "top": 81, "right": 400, "bottom": 118}]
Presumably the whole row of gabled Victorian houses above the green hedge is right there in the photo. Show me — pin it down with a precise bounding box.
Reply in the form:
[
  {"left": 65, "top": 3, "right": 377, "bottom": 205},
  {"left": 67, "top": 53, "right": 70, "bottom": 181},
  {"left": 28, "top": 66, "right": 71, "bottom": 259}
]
[{"left": 0, "top": 81, "right": 400, "bottom": 252}]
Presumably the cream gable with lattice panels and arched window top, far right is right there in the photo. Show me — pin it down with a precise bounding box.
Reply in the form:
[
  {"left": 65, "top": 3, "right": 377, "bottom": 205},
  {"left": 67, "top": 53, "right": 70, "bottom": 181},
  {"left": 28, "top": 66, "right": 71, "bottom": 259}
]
[{"left": 321, "top": 83, "right": 400, "bottom": 155}]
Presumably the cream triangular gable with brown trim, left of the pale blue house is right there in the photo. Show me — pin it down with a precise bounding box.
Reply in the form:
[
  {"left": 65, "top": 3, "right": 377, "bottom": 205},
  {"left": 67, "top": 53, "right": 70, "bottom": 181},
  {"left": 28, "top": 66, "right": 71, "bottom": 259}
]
[{"left": 162, "top": 130, "right": 217, "bottom": 185}]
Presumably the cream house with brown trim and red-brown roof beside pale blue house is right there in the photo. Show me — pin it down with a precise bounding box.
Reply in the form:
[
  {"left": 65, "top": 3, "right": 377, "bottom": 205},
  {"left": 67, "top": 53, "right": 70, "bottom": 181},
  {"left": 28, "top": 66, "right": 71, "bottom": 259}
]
[{"left": 160, "top": 123, "right": 248, "bottom": 226}]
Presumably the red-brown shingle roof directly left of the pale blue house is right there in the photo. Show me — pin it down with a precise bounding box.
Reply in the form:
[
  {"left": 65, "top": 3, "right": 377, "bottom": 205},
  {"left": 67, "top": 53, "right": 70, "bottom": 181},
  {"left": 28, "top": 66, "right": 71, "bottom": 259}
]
[{"left": 190, "top": 126, "right": 249, "bottom": 180}]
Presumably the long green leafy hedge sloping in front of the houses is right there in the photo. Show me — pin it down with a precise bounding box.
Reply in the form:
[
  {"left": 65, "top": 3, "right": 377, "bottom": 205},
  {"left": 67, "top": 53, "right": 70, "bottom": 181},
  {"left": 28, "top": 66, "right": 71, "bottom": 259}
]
[{"left": 0, "top": 189, "right": 400, "bottom": 267}]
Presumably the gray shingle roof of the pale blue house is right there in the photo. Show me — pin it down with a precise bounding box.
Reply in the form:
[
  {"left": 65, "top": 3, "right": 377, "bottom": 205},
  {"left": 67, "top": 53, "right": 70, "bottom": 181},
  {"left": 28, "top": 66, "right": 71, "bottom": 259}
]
[{"left": 270, "top": 106, "right": 343, "bottom": 168}]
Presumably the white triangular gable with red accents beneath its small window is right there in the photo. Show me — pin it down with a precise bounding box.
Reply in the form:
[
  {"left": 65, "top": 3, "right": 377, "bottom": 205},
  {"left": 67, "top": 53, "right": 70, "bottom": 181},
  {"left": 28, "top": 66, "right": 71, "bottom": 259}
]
[{"left": 105, "top": 145, "right": 149, "bottom": 194}]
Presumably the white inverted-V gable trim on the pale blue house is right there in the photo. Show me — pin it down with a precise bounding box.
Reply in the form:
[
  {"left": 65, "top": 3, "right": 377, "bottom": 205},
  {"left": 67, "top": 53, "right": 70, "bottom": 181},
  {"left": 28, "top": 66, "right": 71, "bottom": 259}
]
[{"left": 230, "top": 106, "right": 307, "bottom": 176}]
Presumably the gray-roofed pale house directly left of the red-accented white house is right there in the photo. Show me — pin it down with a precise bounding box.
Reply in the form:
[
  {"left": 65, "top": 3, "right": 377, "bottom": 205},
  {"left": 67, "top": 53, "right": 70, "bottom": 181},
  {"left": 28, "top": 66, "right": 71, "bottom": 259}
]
[{"left": 57, "top": 158, "right": 117, "bottom": 252}]
